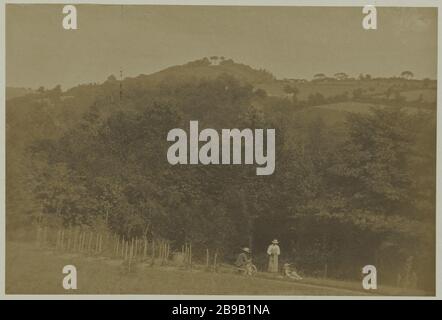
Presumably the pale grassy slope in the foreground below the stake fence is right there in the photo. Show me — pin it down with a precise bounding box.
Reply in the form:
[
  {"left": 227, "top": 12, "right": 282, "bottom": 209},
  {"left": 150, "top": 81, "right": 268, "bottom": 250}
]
[{"left": 6, "top": 242, "right": 428, "bottom": 295}]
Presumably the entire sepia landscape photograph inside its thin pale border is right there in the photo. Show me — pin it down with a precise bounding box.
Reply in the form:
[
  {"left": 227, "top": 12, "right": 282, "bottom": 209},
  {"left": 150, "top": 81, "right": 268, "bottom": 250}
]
[{"left": 4, "top": 3, "right": 438, "bottom": 298}]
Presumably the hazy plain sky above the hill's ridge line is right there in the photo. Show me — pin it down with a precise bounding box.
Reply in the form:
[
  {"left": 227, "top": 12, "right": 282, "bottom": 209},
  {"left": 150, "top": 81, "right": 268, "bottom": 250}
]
[{"left": 6, "top": 4, "right": 437, "bottom": 89}]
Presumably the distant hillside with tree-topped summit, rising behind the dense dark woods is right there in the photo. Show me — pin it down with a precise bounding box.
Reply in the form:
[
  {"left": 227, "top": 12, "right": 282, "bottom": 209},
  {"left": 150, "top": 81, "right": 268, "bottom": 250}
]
[{"left": 6, "top": 57, "right": 437, "bottom": 152}]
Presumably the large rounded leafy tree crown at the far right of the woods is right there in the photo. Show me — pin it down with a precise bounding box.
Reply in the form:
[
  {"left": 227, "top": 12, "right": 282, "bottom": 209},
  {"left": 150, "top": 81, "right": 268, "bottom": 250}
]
[{"left": 331, "top": 108, "right": 415, "bottom": 214}]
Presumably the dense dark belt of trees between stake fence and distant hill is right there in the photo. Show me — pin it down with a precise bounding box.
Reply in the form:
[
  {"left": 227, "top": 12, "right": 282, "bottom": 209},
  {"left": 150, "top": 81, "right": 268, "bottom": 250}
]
[{"left": 8, "top": 75, "right": 436, "bottom": 288}]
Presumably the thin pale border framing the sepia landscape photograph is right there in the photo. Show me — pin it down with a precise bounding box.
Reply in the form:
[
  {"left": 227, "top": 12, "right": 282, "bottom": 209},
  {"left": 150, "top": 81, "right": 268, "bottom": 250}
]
[{"left": 0, "top": 0, "right": 442, "bottom": 300}]
